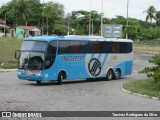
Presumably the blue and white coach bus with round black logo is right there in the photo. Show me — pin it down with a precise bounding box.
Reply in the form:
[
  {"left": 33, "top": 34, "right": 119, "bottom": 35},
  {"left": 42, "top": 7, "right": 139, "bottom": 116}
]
[{"left": 15, "top": 35, "right": 133, "bottom": 85}]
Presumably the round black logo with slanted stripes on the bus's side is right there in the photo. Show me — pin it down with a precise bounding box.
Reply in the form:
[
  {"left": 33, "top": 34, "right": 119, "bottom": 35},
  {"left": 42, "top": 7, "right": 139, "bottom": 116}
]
[{"left": 88, "top": 58, "right": 101, "bottom": 76}]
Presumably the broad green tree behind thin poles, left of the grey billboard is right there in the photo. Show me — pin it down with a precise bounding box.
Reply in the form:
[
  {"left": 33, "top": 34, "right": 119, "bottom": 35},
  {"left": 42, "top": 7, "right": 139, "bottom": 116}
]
[{"left": 72, "top": 10, "right": 101, "bottom": 35}]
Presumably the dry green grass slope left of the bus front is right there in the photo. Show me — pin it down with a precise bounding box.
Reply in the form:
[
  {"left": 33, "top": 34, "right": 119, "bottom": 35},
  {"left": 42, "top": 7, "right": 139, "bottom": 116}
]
[{"left": 0, "top": 37, "right": 22, "bottom": 69}]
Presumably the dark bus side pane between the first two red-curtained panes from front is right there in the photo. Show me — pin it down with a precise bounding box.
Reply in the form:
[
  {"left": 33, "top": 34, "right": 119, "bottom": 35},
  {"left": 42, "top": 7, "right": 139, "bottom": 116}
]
[{"left": 80, "top": 41, "right": 91, "bottom": 53}]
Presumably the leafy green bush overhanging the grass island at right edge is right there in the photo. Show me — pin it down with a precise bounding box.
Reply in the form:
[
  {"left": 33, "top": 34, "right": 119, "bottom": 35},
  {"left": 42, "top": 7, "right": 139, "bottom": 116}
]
[{"left": 140, "top": 54, "right": 160, "bottom": 82}]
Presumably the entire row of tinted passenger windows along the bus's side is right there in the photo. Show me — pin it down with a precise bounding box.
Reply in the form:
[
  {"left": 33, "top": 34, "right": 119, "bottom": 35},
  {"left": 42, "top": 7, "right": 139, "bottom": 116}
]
[{"left": 58, "top": 41, "right": 132, "bottom": 54}]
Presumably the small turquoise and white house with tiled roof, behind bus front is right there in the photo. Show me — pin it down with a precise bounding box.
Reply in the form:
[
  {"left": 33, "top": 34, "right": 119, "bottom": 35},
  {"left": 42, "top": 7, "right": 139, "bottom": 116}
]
[{"left": 16, "top": 26, "right": 41, "bottom": 39}]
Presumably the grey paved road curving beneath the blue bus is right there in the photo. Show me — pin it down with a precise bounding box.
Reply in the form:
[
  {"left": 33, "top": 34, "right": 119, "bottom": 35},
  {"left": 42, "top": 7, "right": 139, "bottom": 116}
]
[{"left": 0, "top": 52, "right": 160, "bottom": 120}]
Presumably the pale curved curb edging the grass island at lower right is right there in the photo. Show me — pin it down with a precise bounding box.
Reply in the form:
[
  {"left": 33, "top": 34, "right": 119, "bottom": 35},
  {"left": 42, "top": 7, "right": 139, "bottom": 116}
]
[{"left": 121, "top": 85, "right": 160, "bottom": 101}]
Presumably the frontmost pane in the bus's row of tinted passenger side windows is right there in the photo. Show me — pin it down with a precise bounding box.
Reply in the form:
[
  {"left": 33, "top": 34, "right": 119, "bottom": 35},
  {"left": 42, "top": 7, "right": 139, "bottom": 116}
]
[{"left": 58, "top": 41, "right": 69, "bottom": 54}]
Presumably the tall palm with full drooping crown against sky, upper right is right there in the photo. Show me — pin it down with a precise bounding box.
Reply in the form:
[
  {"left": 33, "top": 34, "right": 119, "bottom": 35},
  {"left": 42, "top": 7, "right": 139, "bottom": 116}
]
[{"left": 144, "top": 5, "right": 156, "bottom": 23}]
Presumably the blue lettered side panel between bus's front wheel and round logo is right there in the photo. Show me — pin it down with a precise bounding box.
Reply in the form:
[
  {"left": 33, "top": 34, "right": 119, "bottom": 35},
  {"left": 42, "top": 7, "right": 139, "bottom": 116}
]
[{"left": 56, "top": 54, "right": 89, "bottom": 79}]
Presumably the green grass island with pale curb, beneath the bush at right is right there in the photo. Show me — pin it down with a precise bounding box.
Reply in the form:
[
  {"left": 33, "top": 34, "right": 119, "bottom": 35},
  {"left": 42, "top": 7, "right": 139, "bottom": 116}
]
[{"left": 122, "top": 79, "right": 160, "bottom": 99}]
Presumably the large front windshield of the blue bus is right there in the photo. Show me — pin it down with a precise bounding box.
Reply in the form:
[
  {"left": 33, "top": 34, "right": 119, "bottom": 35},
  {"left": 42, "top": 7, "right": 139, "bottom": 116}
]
[{"left": 19, "top": 41, "right": 47, "bottom": 70}]
